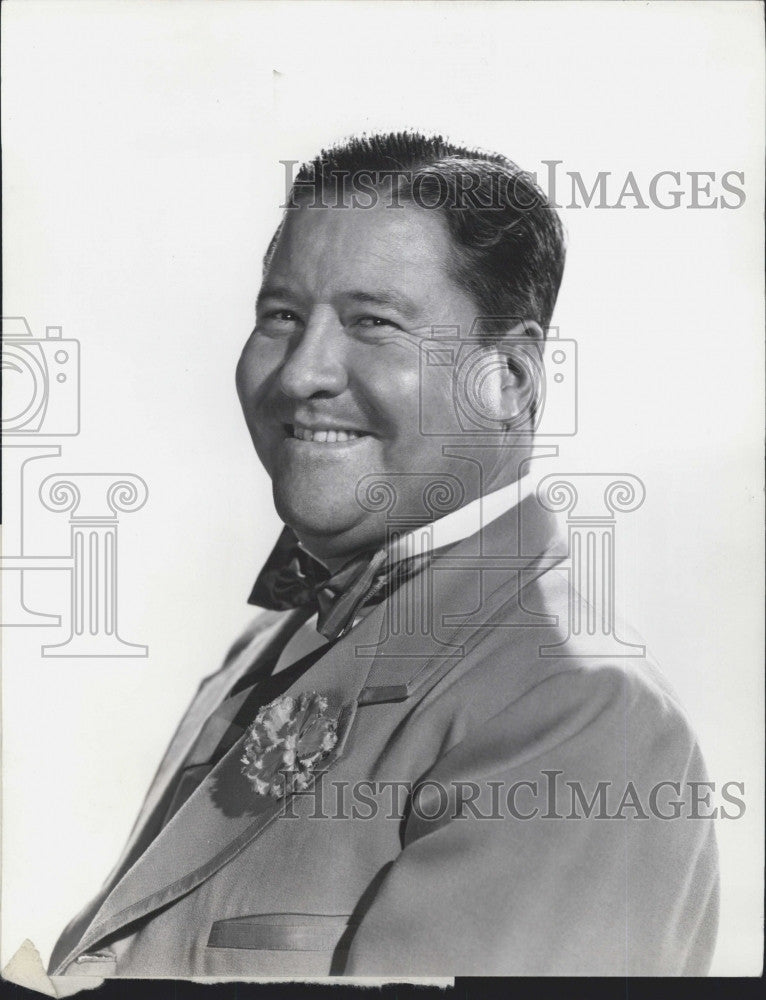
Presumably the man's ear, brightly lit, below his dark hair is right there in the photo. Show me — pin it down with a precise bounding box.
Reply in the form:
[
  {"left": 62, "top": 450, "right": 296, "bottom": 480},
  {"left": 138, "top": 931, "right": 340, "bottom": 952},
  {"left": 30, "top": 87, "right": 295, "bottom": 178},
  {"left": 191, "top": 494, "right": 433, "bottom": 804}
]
[{"left": 497, "top": 320, "right": 545, "bottom": 430}]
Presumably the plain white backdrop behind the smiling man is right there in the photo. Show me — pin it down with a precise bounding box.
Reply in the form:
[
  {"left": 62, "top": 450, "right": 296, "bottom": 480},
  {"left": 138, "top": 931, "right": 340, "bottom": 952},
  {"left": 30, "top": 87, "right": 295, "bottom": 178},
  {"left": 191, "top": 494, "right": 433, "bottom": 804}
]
[{"left": 2, "top": 0, "right": 763, "bottom": 974}]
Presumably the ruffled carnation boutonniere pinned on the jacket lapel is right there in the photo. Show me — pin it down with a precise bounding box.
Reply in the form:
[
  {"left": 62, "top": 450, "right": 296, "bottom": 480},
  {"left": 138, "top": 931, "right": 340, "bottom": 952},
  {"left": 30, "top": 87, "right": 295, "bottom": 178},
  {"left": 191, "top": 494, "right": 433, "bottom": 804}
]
[{"left": 241, "top": 691, "right": 338, "bottom": 798}]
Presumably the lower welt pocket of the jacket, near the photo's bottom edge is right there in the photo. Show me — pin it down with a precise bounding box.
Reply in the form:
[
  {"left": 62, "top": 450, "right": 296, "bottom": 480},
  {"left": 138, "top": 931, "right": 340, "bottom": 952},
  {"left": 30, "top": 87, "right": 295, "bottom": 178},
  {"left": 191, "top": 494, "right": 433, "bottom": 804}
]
[{"left": 207, "top": 913, "right": 354, "bottom": 951}]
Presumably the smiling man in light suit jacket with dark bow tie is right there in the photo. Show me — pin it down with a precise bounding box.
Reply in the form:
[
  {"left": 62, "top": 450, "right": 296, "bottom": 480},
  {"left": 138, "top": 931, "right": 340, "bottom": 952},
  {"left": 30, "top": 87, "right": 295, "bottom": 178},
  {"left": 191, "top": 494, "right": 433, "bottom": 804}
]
[{"left": 51, "top": 134, "right": 717, "bottom": 977}]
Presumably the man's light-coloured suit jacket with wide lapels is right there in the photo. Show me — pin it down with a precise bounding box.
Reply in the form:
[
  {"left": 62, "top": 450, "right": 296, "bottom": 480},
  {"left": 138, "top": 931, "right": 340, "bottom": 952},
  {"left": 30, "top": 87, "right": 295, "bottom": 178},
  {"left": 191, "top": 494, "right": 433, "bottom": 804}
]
[{"left": 51, "top": 497, "right": 718, "bottom": 977}]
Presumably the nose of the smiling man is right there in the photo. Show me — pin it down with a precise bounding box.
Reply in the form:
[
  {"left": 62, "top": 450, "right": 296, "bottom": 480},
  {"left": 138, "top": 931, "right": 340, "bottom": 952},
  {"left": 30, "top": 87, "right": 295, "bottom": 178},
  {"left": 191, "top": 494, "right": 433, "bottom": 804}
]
[{"left": 279, "top": 309, "right": 348, "bottom": 399}]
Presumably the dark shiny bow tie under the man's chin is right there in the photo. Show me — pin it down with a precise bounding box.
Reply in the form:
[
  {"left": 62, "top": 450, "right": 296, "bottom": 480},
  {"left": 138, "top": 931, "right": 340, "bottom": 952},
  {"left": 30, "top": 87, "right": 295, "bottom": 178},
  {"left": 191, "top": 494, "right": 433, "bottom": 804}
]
[{"left": 248, "top": 527, "right": 430, "bottom": 642}]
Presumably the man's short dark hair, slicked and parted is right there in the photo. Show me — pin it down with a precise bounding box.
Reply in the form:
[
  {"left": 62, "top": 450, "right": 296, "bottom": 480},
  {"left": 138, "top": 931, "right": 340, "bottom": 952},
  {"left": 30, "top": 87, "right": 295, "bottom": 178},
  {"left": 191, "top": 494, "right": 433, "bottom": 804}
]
[{"left": 265, "top": 132, "right": 565, "bottom": 333}]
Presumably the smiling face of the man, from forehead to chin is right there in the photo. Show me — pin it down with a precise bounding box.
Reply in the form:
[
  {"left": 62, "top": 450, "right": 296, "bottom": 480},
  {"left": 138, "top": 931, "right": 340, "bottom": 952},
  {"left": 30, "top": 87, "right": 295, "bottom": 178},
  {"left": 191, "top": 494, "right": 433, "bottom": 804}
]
[{"left": 237, "top": 199, "right": 520, "bottom": 563}]
